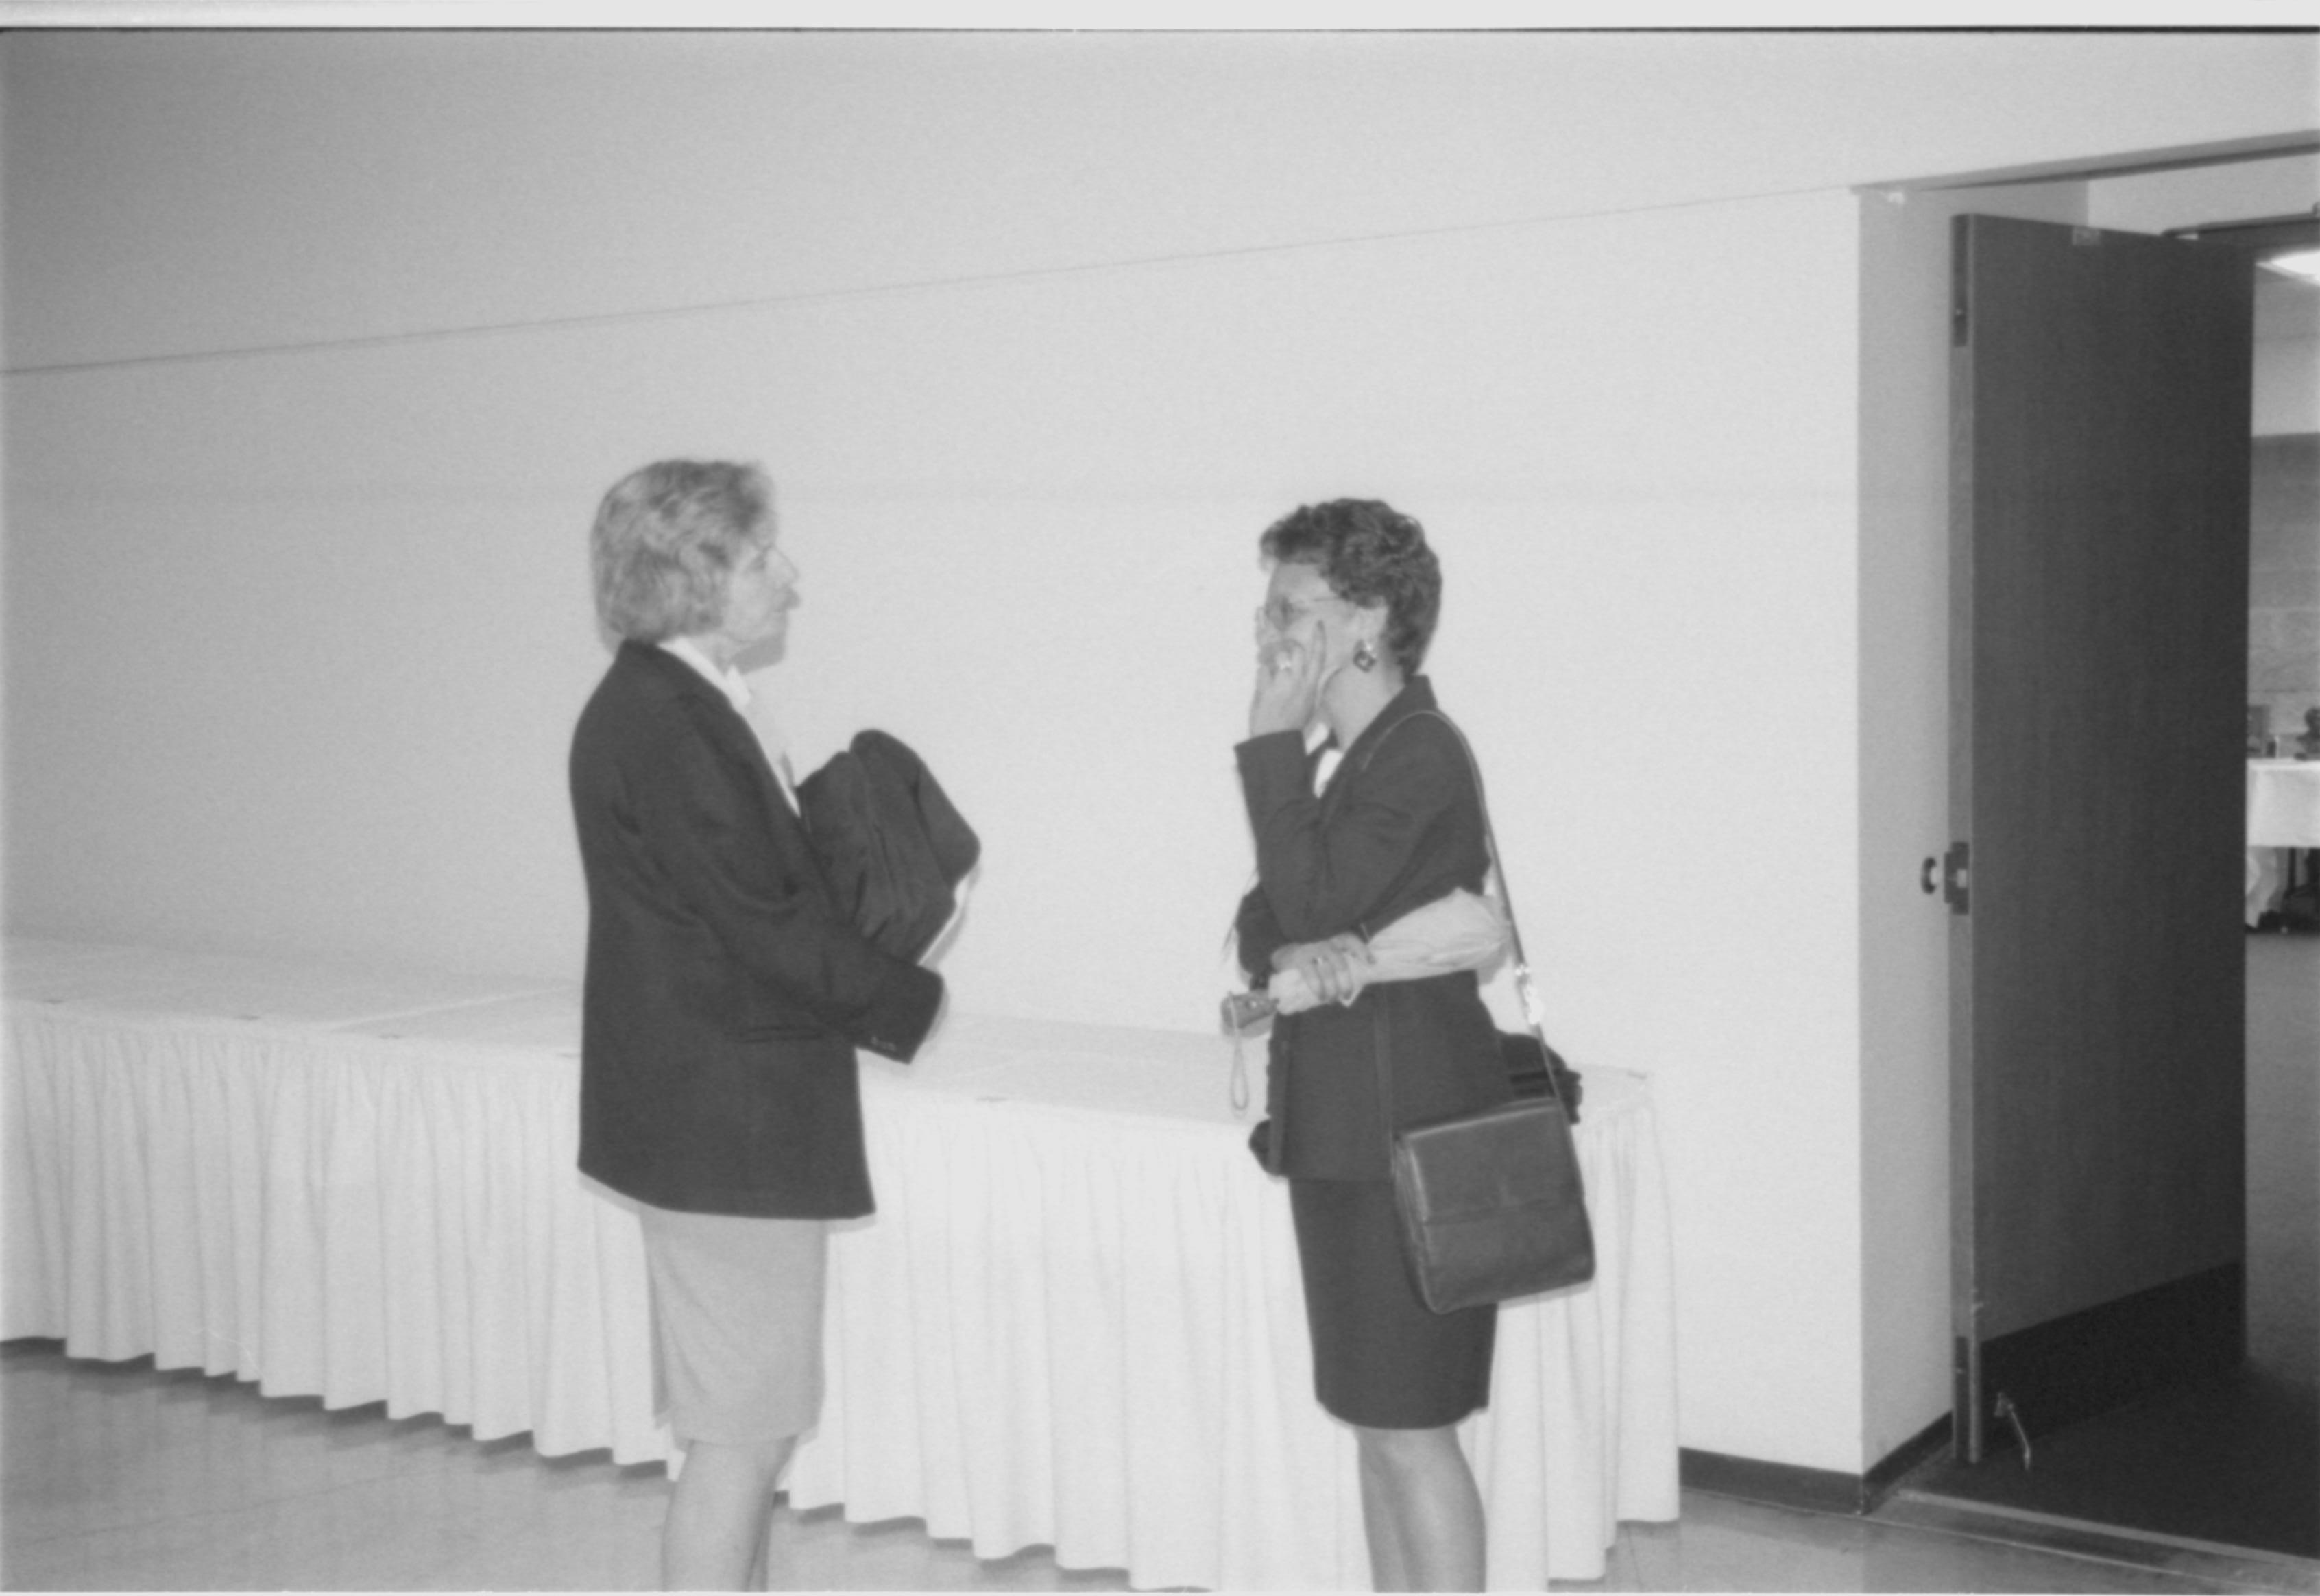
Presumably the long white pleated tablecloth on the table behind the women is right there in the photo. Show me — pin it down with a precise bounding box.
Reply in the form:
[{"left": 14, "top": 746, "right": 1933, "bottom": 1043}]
[{"left": 0, "top": 942, "right": 1678, "bottom": 1589}]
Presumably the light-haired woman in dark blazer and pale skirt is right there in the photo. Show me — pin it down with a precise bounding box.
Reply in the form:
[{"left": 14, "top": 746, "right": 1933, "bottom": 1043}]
[{"left": 570, "top": 459, "right": 942, "bottom": 1589}]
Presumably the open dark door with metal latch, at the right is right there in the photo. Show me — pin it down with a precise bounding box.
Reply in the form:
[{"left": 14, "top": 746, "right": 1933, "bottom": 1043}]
[{"left": 1951, "top": 216, "right": 2253, "bottom": 1462}]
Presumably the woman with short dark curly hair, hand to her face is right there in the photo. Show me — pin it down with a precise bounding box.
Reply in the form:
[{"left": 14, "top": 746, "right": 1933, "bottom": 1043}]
[{"left": 1234, "top": 499, "right": 1512, "bottom": 1591}]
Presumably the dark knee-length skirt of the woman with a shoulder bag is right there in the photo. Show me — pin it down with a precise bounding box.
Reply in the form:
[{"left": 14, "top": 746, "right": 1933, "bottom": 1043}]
[{"left": 1290, "top": 1178, "right": 1499, "bottom": 1429}]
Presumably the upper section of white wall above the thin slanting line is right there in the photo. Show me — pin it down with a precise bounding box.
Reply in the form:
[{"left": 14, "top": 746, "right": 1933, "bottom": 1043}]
[{"left": 7, "top": 32, "right": 2315, "bottom": 380}]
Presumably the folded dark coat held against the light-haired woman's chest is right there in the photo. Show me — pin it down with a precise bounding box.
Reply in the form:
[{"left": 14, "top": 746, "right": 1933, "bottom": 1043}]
[{"left": 798, "top": 731, "right": 984, "bottom": 958}]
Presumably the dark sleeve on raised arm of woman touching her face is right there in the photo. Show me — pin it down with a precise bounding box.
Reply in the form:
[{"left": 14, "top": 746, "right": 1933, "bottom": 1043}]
[{"left": 1234, "top": 717, "right": 1473, "bottom": 958}]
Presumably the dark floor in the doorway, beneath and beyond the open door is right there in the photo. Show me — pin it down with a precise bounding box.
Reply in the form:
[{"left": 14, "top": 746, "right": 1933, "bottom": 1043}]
[{"left": 1907, "top": 165, "right": 2320, "bottom": 1559}]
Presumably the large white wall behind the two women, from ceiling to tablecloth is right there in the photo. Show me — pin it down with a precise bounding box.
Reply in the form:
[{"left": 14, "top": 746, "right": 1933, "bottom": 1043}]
[{"left": 0, "top": 35, "right": 2313, "bottom": 1471}]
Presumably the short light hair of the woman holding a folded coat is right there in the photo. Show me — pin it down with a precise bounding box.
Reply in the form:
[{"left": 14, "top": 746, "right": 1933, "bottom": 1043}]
[{"left": 590, "top": 459, "right": 773, "bottom": 642}]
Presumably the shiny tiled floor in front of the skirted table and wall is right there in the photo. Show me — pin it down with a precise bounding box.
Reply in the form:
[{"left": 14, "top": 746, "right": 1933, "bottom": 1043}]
[{"left": 0, "top": 1341, "right": 2320, "bottom": 1591}]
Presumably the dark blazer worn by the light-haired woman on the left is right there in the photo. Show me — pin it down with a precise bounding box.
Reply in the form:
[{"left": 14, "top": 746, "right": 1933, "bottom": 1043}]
[{"left": 570, "top": 642, "right": 942, "bottom": 1218}]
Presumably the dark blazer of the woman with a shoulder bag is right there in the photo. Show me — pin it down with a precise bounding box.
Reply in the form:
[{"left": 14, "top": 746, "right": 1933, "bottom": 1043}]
[{"left": 1234, "top": 677, "right": 1512, "bottom": 1181}]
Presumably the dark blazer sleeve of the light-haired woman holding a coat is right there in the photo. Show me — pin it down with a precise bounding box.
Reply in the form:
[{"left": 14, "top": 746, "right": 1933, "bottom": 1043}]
[{"left": 638, "top": 705, "right": 942, "bottom": 1060}]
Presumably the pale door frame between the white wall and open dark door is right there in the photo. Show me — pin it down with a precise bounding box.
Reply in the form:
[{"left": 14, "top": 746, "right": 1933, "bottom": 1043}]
[{"left": 1856, "top": 132, "right": 2320, "bottom": 1485}]
